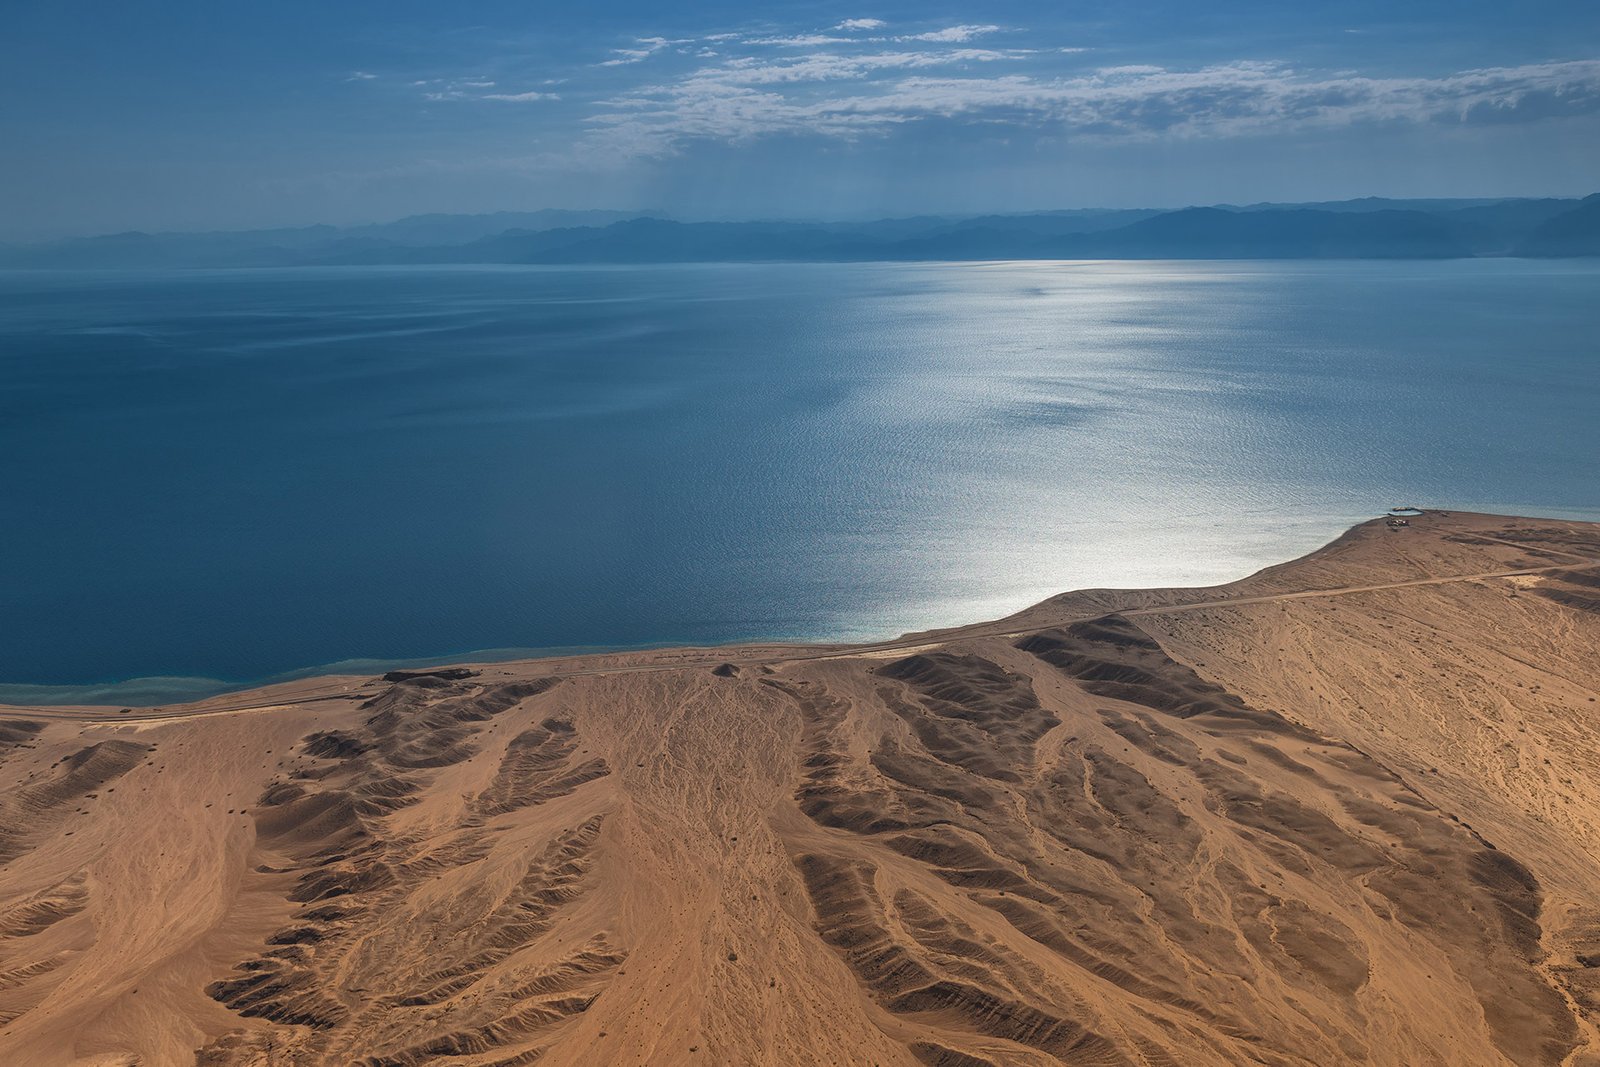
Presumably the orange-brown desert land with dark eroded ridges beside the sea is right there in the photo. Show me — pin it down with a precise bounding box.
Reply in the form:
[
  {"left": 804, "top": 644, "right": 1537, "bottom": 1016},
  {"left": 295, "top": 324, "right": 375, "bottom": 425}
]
[{"left": 0, "top": 512, "right": 1600, "bottom": 1067}]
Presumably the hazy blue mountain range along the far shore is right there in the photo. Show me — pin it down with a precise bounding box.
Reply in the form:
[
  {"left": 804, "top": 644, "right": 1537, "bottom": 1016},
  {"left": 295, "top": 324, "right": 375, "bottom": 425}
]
[{"left": 0, "top": 194, "right": 1600, "bottom": 269}]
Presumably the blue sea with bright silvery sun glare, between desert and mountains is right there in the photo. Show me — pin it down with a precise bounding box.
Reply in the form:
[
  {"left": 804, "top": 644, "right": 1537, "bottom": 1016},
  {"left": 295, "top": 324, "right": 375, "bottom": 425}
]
[{"left": 0, "top": 259, "right": 1600, "bottom": 699}]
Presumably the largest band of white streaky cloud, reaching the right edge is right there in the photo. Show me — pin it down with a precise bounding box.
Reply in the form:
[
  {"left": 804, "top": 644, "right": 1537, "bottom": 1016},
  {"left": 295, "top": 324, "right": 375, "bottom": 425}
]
[{"left": 589, "top": 50, "right": 1600, "bottom": 155}]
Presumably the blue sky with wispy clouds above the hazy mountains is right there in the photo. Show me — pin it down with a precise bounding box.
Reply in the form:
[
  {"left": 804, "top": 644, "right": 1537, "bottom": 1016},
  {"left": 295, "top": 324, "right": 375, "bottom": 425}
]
[{"left": 0, "top": 0, "right": 1600, "bottom": 240}]
